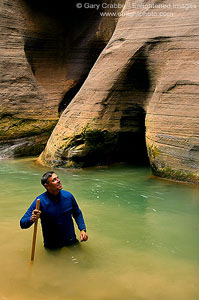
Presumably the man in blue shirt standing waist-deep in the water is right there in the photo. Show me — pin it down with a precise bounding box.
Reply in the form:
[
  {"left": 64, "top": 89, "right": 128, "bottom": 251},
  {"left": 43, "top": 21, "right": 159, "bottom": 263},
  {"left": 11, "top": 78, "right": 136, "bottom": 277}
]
[{"left": 20, "top": 171, "right": 88, "bottom": 248}]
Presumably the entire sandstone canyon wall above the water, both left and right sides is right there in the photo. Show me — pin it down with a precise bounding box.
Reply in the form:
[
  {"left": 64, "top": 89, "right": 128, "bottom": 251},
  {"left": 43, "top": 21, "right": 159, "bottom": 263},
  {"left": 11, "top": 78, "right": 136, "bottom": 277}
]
[{"left": 0, "top": 0, "right": 199, "bottom": 183}]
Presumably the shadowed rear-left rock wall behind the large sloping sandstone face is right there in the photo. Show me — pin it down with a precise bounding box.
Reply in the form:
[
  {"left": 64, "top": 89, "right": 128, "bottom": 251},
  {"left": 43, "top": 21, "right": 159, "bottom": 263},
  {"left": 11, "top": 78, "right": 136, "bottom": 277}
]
[{"left": 0, "top": 0, "right": 122, "bottom": 157}]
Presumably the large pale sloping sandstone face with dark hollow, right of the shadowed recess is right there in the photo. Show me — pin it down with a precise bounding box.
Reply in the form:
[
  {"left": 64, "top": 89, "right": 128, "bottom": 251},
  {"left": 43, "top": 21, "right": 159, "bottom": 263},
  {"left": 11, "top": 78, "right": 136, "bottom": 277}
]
[{"left": 38, "top": 0, "right": 199, "bottom": 183}]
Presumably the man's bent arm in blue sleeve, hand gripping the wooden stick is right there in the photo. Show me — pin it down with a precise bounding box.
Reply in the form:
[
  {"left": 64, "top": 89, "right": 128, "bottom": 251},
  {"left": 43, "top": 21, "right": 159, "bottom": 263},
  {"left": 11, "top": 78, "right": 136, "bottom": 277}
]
[{"left": 20, "top": 198, "right": 41, "bottom": 229}]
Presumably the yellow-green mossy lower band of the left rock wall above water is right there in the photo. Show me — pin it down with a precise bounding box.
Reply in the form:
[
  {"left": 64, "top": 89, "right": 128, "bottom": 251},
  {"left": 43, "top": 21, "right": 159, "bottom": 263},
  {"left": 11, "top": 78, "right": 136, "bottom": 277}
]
[{"left": 0, "top": 113, "right": 57, "bottom": 157}]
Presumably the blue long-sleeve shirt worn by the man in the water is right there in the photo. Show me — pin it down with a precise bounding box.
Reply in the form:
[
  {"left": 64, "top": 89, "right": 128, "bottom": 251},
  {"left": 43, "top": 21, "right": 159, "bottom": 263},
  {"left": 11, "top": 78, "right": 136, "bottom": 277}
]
[{"left": 20, "top": 190, "right": 86, "bottom": 248}]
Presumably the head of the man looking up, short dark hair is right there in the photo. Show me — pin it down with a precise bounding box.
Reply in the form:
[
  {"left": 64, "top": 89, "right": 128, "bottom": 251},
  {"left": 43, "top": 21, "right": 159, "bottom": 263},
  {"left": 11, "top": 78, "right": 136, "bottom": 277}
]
[{"left": 41, "top": 171, "right": 62, "bottom": 195}]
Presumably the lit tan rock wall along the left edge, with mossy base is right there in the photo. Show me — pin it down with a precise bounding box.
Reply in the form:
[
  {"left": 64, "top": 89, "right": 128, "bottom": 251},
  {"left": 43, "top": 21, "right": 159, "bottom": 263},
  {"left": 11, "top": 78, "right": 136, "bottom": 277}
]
[{"left": 0, "top": 1, "right": 56, "bottom": 157}]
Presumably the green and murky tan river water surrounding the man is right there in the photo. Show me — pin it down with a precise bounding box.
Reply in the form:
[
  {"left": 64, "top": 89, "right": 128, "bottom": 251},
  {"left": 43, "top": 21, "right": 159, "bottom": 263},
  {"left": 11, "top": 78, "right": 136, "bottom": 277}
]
[{"left": 0, "top": 158, "right": 199, "bottom": 300}]
